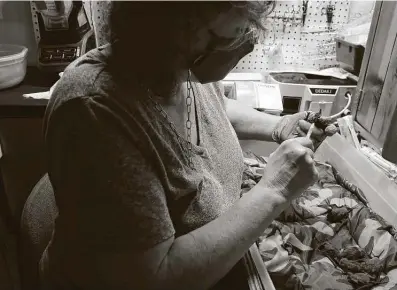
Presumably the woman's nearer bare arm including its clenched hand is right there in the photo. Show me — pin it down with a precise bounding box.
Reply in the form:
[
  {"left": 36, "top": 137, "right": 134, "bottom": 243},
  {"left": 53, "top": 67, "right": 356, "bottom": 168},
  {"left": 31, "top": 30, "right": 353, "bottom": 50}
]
[{"left": 106, "top": 138, "right": 317, "bottom": 290}]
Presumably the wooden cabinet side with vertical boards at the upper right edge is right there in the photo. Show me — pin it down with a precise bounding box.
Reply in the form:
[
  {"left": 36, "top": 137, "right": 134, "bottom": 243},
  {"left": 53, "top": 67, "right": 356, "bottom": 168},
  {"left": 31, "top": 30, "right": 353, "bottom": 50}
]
[{"left": 353, "top": 1, "right": 397, "bottom": 163}]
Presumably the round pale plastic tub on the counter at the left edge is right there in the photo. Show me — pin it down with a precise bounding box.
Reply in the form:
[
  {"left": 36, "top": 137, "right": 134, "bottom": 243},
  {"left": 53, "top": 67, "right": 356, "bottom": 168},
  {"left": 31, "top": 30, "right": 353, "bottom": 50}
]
[{"left": 0, "top": 44, "right": 28, "bottom": 90}]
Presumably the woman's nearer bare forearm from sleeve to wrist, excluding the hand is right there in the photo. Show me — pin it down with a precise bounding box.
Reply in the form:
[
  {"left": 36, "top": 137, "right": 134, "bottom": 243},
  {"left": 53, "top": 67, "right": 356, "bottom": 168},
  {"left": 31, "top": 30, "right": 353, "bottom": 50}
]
[{"left": 135, "top": 185, "right": 288, "bottom": 290}]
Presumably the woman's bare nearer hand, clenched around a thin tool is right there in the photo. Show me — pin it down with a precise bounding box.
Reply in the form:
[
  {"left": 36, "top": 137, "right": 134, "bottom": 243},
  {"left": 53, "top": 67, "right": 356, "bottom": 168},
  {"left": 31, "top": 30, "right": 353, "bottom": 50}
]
[{"left": 260, "top": 138, "right": 318, "bottom": 201}]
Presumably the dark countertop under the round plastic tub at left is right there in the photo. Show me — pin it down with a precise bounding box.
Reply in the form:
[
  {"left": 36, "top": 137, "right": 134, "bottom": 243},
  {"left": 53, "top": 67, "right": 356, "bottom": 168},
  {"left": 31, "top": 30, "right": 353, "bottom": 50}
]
[{"left": 0, "top": 67, "right": 59, "bottom": 118}]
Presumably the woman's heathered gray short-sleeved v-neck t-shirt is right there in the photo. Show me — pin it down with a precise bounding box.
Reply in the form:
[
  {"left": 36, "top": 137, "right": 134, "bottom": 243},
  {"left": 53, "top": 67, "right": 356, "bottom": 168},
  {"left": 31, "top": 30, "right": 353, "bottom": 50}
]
[{"left": 44, "top": 46, "right": 248, "bottom": 289}]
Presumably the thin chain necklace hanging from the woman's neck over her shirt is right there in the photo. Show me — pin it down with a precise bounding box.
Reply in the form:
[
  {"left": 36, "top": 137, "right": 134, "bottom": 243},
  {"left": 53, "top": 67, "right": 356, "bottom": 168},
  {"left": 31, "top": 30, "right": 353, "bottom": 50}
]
[{"left": 149, "top": 70, "right": 196, "bottom": 167}]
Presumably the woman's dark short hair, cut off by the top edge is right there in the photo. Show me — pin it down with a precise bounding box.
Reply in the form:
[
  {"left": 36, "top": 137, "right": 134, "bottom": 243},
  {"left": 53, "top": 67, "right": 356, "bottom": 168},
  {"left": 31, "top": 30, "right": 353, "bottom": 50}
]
[{"left": 109, "top": 1, "right": 275, "bottom": 92}]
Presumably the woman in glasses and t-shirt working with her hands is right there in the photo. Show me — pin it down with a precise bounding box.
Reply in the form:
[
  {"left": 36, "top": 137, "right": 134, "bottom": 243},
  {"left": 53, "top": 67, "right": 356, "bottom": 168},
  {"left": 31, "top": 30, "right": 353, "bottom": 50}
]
[{"left": 41, "top": 1, "right": 334, "bottom": 289}]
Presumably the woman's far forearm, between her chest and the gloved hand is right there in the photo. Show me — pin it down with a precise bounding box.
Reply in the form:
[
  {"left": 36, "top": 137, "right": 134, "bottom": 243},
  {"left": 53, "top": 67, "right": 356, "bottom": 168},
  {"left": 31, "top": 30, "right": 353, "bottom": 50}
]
[{"left": 224, "top": 97, "right": 281, "bottom": 141}]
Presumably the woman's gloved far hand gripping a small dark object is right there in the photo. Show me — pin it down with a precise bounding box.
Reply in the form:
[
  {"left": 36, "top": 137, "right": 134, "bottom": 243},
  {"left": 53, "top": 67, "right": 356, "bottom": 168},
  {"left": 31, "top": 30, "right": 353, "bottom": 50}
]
[{"left": 272, "top": 111, "right": 337, "bottom": 148}]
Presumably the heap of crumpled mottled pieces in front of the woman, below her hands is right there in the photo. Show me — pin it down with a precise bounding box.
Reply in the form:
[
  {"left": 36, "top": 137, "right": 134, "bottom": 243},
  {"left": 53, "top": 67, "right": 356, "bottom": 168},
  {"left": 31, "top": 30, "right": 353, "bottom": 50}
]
[{"left": 242, "top": 153, "right": 397, "bottom": 290}]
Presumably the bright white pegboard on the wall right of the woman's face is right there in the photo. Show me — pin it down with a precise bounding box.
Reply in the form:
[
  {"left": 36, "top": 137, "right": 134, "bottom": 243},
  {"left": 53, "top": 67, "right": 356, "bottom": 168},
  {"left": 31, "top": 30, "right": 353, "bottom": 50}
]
[{"left": 233, "top": 0, "right": 375, "bottom": 73}]
